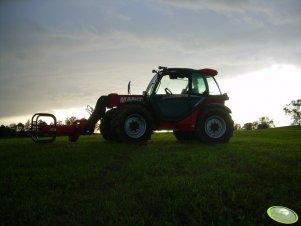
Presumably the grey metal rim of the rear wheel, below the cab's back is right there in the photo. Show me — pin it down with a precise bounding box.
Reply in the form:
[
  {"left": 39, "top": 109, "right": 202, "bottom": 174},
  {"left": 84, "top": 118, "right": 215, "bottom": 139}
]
[{"left": 205, "top": 116, "right": 227, "bottom": 139}]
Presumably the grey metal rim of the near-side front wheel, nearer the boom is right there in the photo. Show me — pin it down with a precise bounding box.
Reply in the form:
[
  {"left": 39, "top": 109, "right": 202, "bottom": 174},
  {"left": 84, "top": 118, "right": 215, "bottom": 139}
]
[{"left": 124, "top": 114, "right": 146, "bottom": 139}]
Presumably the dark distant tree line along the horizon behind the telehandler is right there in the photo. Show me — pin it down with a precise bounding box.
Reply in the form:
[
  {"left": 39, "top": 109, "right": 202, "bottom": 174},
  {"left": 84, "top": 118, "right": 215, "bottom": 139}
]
[{"left": 0, "top": 99, "right": 301, "bottom": 137}]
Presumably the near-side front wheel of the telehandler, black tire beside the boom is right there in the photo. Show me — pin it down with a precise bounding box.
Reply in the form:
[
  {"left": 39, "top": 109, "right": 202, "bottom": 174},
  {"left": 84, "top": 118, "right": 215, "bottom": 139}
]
[{"left": 111, "top": 104, "right": 153, "bottom": 143}]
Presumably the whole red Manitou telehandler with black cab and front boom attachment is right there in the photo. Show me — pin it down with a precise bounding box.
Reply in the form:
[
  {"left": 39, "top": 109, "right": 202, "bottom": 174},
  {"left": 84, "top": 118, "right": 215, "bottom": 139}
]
[{"left": 31, "top": 66, "right": 234, "bottom": 143}]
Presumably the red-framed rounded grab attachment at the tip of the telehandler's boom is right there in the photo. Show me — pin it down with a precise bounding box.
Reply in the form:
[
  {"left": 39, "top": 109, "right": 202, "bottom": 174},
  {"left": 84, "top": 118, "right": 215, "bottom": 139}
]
[{"left": 31, "top": 113, "right": 57, "bottom": 143}]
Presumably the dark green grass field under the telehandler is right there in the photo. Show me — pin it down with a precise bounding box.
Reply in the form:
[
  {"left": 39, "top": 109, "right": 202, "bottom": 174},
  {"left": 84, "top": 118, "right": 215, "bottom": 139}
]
[{"left": 0, "top": 127, "right": 301, "bottom": 226}]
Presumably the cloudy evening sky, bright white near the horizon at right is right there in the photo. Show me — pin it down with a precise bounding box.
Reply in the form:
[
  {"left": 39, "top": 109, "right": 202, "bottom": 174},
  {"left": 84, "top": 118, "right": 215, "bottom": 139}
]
[{"left": 0, "top": 0, "right": 301, "bottom": 126}]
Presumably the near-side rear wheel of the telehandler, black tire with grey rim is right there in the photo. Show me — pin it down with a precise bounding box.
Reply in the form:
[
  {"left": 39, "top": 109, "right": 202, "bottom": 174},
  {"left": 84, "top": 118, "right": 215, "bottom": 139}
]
[{"left": 196, "top": 108, "right": 234, "bottom": 144}]
